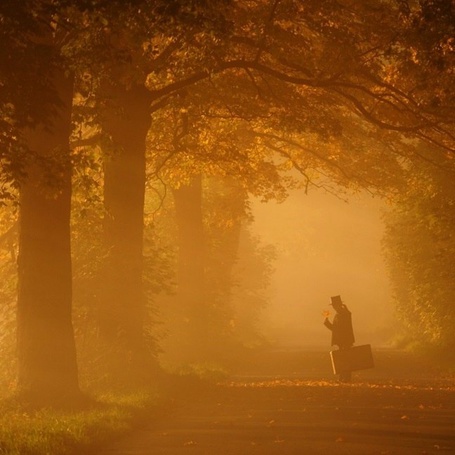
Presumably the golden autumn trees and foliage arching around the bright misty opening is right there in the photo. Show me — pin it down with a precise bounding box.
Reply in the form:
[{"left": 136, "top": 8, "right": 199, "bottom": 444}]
[{"left": 0, "top": 0, "right": 455, "bottom": 406}]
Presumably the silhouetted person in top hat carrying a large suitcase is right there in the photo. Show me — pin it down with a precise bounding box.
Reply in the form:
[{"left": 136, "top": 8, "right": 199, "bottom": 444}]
[{"left": 324, "top": 295, "right": 355, "bottom": 382}]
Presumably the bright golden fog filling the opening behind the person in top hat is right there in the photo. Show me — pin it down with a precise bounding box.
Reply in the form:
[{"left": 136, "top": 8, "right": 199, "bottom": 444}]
[{"left": 252, "top": 191, "right": 395, "bottom": 347}]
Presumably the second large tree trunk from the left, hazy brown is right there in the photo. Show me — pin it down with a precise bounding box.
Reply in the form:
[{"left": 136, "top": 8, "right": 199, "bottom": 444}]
[{"left": 99, "top": 86, "right": 151, "bottom": 382}]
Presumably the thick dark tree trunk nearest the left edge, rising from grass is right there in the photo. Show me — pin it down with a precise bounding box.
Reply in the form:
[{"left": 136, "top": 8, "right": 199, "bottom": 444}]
[{"left": 17, "top": 72, "right": 79, "bottom": 402}]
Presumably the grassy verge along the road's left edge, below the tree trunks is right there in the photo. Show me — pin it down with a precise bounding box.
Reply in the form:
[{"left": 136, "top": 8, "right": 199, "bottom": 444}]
[{"left": 0, "top": 365, "right": 225, "bottom": 455}]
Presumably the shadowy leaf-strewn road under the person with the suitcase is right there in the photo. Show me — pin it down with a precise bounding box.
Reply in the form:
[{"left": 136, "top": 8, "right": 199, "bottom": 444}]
[{"left": 96, "top": 349, "right": 455, "bottom": 455}]
